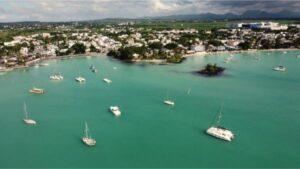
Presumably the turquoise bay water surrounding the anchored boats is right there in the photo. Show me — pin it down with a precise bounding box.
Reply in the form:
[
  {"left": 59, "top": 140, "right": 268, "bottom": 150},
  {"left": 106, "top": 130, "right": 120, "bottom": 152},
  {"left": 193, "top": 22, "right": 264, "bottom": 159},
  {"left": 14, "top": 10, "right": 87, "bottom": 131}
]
[{"left": 0, "top": 51, "right": 300, "bottom": 168}]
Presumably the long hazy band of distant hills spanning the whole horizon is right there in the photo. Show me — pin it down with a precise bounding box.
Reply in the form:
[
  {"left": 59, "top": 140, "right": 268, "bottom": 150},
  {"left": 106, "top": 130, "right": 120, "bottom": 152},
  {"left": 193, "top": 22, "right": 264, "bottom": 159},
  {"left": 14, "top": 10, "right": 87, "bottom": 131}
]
[{"left": 0, "top": 10, "right": 300, "bottom": 26}]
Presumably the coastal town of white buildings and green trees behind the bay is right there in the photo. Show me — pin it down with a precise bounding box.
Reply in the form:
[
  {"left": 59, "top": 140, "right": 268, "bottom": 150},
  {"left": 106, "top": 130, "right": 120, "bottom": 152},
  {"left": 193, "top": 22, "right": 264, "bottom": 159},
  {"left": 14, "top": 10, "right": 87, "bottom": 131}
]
[{"left": 0, "top": 22, "right": 300, "bottom": 71}]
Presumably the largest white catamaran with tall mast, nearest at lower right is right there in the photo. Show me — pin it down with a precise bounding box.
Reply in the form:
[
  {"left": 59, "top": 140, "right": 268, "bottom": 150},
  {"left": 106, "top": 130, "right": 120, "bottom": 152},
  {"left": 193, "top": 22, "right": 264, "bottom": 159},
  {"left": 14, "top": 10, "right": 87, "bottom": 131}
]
[{"left": 206, "top": 106, "right": 234, "bottom": 141}]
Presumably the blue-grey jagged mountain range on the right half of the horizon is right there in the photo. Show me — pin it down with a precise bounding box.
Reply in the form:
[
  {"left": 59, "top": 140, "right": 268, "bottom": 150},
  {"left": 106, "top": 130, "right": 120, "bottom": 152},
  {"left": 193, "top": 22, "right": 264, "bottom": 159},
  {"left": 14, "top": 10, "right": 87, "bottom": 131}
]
[{"left": 150, "top": 10, "right": 300, "bottom": 20}]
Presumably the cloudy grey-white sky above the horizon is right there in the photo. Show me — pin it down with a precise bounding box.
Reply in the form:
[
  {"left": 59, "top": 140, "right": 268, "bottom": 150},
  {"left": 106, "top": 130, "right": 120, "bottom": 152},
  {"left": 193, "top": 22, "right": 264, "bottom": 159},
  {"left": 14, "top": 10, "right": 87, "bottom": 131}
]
[{"left": 0, "top": 0, "right": 300, "bottom": 22}]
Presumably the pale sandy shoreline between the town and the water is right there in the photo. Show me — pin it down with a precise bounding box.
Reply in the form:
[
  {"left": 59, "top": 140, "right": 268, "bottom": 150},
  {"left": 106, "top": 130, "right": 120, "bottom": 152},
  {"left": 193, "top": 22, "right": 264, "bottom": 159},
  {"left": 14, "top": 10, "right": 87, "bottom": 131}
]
[{"left": 0, "top": 48, "right": 300, "bottom": 73}]
